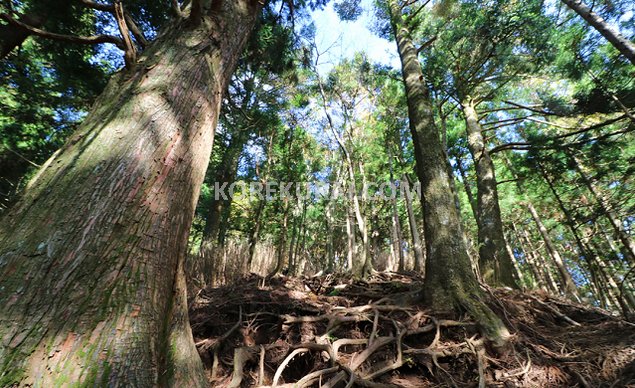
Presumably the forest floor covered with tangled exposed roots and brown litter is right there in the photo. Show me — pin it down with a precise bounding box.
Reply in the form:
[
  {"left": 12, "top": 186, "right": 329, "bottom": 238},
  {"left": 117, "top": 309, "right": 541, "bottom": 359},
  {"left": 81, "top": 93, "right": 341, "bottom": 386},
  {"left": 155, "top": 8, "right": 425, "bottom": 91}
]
[{"left": 190, "top": 274, "right": 635, "bottom": 387}]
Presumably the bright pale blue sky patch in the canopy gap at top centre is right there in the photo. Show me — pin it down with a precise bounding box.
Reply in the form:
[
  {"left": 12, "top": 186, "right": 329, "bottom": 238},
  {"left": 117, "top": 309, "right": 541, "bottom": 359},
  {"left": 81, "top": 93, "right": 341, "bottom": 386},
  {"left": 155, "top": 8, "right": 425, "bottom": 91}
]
[{"left": 313, "top": 0, "right": 399, "bottom": 74}]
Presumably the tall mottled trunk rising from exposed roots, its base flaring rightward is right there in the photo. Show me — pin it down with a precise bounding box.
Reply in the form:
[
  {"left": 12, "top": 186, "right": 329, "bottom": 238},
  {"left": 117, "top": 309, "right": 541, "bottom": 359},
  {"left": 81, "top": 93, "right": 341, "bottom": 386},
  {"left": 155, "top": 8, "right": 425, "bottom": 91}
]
[{"left": 387, "top": 0, "right": 509, "bottom": 346}]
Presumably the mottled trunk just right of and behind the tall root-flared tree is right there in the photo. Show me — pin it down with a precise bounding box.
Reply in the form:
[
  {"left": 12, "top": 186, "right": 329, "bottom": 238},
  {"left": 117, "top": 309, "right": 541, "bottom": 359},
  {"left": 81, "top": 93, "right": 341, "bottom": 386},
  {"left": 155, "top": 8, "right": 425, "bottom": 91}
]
[{"left": 461, "top": 99, "right": 518, "bottom": 288}]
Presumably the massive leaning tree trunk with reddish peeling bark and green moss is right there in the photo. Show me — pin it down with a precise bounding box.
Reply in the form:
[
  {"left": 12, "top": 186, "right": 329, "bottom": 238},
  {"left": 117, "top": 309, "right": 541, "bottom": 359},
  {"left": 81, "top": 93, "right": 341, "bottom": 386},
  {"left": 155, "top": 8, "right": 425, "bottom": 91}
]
[{"left": 0, "top": 0, "right": 260, "bottom": 387}]
